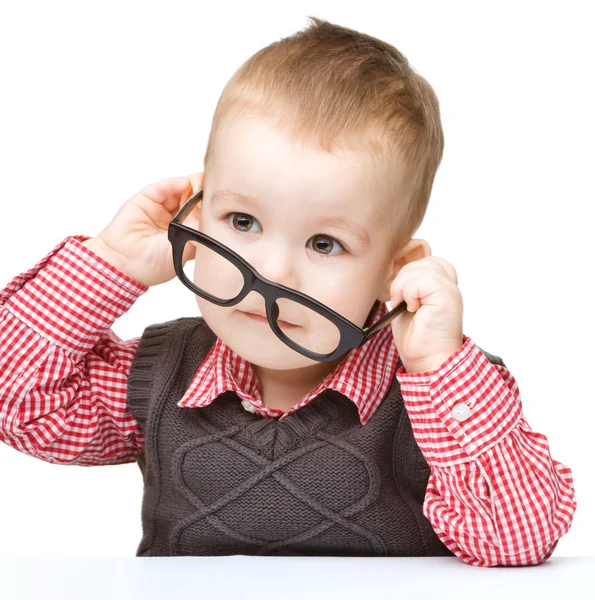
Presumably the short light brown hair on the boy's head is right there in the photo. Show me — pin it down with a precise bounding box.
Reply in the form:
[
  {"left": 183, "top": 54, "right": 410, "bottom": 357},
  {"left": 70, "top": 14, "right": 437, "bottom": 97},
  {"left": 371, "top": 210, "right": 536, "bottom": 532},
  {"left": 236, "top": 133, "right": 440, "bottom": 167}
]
[{"left": 204, "top": 17, "right": 444, "bottom": 253}]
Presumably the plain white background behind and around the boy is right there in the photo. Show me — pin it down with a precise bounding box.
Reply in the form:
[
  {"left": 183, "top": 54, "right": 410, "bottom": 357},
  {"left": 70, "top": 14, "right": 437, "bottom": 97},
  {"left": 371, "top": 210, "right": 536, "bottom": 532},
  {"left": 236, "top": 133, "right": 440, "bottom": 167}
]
[{"left": 0, "top": 0, "right": 595, "bottom": 556}]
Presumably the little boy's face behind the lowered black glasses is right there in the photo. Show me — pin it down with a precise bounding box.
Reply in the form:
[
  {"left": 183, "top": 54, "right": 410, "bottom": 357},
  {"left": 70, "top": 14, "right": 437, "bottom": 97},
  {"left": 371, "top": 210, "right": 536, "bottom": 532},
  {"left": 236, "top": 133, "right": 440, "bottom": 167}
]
[{"left": 194, "top": 119, "right": 414, "bottom": 372}]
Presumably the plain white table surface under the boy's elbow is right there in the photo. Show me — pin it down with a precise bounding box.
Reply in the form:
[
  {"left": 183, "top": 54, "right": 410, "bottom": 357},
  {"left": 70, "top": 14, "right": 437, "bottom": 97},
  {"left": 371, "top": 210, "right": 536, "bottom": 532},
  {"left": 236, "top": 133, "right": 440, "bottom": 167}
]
[{"left": 0, "top": 555, "right": 595, "bottom": 600}]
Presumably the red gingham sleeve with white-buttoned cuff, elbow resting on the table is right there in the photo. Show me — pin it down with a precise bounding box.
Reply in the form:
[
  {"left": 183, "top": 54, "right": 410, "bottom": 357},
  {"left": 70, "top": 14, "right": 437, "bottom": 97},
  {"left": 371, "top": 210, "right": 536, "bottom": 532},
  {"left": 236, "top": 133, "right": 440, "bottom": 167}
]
[{"left": 396, "top": 335, "right": 576, "bottom": 567}]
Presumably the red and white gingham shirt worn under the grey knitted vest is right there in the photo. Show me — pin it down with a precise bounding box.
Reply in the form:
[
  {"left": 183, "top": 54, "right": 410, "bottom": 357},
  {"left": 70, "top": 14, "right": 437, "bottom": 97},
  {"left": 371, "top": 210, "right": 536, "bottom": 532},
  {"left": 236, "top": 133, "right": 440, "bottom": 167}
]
[{"left": 0, "top": 235, "right": 576, "bottom": 566}]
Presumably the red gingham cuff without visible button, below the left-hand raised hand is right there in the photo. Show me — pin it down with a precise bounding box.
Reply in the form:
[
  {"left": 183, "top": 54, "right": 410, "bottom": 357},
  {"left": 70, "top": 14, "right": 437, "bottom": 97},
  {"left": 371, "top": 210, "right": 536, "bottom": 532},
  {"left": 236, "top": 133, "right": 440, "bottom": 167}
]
[{"left": 0, "top": 235, "right": 149, "bottom": 355}]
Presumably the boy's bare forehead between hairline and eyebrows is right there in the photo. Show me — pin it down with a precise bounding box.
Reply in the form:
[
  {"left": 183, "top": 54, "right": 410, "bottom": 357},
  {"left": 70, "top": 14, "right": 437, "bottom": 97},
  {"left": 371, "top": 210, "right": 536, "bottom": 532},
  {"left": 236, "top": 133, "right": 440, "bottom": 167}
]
[{"left": 206, "top": 118, "right": 394, "bottom": 221}]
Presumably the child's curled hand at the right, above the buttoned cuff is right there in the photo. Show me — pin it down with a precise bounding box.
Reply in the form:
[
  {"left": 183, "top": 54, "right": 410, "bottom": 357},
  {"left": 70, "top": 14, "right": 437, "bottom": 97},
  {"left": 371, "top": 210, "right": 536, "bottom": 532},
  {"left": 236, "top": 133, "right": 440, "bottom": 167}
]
[{"left": 390, "top": 256, "right": 463, "bottom": 373}]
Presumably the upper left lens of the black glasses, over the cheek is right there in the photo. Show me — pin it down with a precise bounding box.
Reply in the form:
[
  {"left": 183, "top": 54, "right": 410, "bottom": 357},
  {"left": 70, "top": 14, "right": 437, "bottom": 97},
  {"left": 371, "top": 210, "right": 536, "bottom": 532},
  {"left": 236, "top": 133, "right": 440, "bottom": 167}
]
[{"left": 183, "top": 240, "right": 244, "bottom": 300}]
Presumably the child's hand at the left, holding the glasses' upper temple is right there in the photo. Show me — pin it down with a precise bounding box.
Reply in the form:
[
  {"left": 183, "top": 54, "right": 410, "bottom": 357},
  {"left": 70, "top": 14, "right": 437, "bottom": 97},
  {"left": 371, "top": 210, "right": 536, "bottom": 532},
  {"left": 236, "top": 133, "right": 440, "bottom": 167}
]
[{"left": 82, "top": 173, "right": 203, "bottom": 286}]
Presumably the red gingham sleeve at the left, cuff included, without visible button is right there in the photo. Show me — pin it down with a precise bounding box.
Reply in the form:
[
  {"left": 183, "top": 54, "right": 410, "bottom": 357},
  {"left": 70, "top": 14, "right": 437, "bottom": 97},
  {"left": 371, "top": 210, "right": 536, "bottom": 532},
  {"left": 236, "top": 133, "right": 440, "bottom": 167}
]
[{"left": 0, "top": 235, "right": 148, "bottom": 466}]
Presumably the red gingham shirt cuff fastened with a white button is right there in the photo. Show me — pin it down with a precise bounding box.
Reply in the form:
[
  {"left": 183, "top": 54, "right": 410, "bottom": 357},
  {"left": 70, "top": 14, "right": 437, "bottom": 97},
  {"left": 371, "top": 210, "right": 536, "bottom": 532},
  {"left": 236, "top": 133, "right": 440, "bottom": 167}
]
[{"left": 396, "top": 335, "right": 522, "bottom": 466}]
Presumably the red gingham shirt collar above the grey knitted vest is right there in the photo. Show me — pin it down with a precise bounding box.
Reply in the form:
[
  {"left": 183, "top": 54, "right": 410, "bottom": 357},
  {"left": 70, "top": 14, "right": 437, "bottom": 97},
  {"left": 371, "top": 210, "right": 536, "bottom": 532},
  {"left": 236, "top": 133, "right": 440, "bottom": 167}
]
[{"left": 178, "top": 301, "right": 399, "bottom": 425}]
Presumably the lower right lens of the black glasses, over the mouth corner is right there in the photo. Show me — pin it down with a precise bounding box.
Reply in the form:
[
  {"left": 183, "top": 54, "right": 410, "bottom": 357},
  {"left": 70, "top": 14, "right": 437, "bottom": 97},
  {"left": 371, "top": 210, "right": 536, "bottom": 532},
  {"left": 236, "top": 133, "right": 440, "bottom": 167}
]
[{"left": 268, "top": 298, "right": 341, "bottom": 354}]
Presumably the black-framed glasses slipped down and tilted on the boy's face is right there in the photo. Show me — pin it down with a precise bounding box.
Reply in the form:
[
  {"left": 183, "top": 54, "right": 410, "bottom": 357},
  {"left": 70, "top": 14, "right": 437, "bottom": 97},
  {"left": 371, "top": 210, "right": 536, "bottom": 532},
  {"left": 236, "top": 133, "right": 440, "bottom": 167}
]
[{"left": 168, "top": 189, "right": 407, "bottom": 362}]
